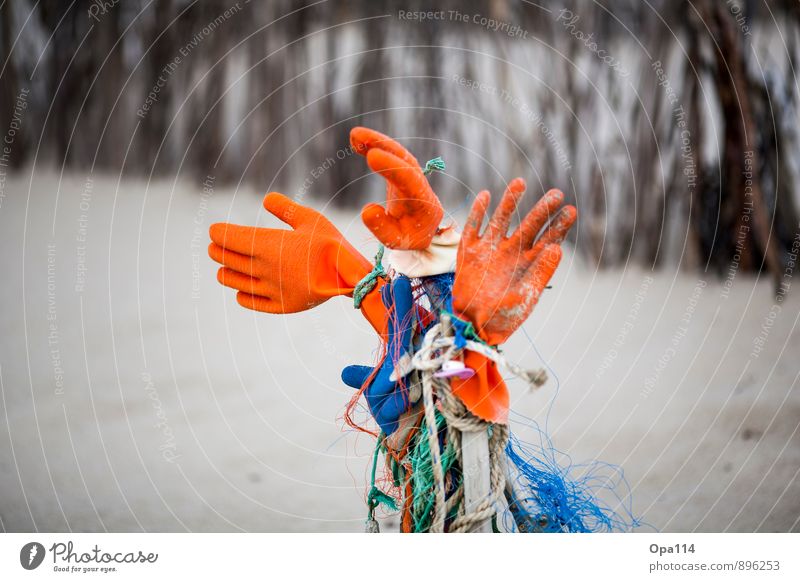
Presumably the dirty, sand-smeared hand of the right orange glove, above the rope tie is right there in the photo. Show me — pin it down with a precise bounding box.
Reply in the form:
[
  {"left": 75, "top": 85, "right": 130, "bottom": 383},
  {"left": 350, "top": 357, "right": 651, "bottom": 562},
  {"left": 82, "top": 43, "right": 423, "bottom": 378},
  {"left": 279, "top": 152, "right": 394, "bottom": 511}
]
[{"left": 453, "top": 178, "right": 577, "bottom": 345}]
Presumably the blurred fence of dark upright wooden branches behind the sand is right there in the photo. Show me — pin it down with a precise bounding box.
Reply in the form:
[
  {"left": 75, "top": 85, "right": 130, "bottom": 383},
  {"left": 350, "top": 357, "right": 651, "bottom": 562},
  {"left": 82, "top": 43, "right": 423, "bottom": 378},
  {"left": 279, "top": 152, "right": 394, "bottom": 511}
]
[{"left": 0, "top": 0, "right": 800, "bottom": 280}]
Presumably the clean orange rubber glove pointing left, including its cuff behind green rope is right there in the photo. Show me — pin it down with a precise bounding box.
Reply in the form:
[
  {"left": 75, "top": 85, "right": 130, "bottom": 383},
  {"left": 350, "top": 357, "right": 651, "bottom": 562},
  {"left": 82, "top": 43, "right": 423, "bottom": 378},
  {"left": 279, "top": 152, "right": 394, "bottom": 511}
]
[{"left": 208, "top": 192, "right": 387, "bottom": 333}]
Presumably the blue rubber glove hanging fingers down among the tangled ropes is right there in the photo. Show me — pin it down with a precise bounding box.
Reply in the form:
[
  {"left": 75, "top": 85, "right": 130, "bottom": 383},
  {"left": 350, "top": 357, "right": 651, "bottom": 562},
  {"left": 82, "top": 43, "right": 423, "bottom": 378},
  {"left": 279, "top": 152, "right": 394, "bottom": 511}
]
[{"left": 342, "top": 275, "right": 414, "bottom": 436}]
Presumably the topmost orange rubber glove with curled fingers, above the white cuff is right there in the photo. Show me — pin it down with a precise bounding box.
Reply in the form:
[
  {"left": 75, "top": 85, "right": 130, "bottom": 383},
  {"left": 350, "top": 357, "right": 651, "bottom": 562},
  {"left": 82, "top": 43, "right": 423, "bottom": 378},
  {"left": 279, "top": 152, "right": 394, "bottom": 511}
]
[{"left": 350, "top": 127, "right": 444, "bottom": 250}]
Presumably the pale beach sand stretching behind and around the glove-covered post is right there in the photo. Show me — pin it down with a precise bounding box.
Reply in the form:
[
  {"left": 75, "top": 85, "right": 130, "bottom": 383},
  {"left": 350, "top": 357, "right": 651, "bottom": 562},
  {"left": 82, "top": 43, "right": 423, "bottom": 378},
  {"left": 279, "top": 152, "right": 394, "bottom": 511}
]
[{"left": 0, "top": 171, "right": 800, "bottom": 532}]
